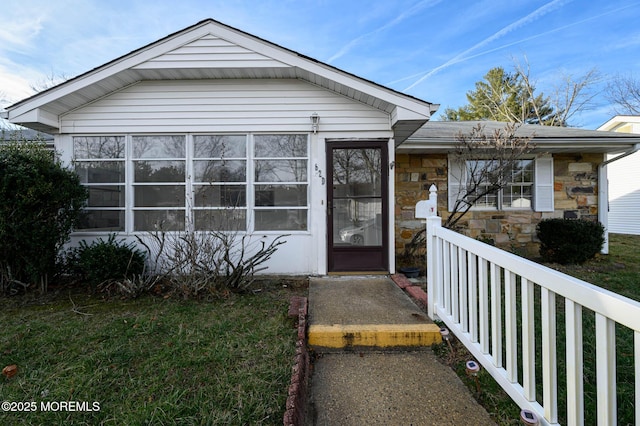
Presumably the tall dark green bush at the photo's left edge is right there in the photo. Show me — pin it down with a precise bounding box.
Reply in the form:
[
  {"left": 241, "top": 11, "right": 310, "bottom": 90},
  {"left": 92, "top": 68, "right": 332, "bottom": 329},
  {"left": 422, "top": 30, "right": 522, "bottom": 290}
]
[{"left": 0, "top": 132, "right": 87, "bottom": 293}]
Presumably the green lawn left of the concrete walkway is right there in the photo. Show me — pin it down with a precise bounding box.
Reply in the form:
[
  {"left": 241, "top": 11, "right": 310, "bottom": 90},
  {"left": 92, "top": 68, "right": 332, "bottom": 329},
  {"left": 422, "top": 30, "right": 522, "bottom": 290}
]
[{"left": 0, "top": 283, "right": 306, "bottom": 425}]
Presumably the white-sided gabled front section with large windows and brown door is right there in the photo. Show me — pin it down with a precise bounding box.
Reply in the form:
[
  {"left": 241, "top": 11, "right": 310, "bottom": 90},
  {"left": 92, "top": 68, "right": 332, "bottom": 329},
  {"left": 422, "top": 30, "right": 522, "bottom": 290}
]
[{"left": 5, "top": 19, "right": 437, "bottom": 274}]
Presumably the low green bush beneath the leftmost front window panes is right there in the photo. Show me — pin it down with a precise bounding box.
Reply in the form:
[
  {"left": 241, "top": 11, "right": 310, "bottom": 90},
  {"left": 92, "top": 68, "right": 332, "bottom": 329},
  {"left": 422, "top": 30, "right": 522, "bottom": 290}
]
[{"left": 67, "top": 234, "right": 145, "bottom": 287}]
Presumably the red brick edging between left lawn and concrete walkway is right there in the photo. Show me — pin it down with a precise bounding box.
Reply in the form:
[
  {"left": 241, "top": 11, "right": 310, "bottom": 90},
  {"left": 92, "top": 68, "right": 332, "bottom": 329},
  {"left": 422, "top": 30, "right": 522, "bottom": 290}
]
[{"left": 283, "top": 296, "right": 310, "bottom": 426}]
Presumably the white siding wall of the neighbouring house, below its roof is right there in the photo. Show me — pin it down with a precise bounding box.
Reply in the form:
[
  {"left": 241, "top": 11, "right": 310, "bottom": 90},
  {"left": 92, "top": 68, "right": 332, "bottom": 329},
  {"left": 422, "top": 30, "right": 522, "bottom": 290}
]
[{"left": 607, "top": 153, "right": 640, "bottom": 235}]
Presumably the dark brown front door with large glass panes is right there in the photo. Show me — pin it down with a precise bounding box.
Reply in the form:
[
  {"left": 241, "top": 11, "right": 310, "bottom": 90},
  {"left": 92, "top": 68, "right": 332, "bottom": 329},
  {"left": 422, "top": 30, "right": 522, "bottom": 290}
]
[{"left": 327, "top": 142, "right": 389, "bottom": 272}]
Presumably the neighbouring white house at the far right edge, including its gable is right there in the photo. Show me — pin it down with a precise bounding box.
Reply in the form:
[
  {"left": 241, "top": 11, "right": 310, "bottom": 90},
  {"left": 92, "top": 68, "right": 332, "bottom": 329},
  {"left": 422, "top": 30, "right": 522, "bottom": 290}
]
[{"left": 598, "top": 115, "right": 640, "bottom": 235}]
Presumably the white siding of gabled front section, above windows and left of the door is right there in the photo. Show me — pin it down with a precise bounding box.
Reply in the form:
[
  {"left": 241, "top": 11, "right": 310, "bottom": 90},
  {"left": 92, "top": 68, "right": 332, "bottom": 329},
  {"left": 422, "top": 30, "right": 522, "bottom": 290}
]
[{"left": 56, "top": 79, "right": 393, "bottom": 274}]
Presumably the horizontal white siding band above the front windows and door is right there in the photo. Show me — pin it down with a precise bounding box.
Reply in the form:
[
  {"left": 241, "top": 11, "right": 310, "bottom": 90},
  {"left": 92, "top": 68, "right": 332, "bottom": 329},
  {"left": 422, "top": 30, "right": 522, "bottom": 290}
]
[{"left": 61, "top": 80, "right": 390, "bottom": 137}]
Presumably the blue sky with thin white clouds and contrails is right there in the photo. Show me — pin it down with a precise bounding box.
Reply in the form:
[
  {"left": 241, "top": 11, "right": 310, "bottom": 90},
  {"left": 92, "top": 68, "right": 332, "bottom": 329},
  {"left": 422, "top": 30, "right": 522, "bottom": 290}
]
[{"left": 0, "top": 0, "right": 640, "bottom": 129}]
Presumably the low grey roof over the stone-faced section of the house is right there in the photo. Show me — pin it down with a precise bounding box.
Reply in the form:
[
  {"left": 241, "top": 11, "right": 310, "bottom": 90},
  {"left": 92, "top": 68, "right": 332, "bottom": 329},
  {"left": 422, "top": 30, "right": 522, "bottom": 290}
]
[{"left": 396, "top": 121, "right": 640, "bottom": 153}]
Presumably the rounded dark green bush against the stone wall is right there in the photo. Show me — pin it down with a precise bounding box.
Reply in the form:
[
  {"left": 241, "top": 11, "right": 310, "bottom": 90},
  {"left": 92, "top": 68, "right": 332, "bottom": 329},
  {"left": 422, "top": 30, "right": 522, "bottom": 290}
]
[{"left": 536, "top": 219, "right": 604, "bottom": 264}]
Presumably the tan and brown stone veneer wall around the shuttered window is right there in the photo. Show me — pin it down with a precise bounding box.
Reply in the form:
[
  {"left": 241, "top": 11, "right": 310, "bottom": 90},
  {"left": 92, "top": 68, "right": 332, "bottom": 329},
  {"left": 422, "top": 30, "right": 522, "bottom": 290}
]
[{"left": 395, "top": 154, "right": 603, "bottom": 260}]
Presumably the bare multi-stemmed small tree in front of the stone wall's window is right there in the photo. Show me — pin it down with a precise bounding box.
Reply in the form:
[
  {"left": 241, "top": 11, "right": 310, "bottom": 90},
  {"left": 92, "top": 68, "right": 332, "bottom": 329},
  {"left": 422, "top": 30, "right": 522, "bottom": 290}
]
[{"left": 444, "top": 124, "right": 534, "bottom": 228}]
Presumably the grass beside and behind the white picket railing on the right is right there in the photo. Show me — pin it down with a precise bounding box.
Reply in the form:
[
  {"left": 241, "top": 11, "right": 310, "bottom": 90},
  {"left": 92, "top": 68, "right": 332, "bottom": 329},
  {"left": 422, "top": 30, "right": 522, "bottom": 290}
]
[{"left": 434, "top": 234, "right": 640, "bottom": 425}]
